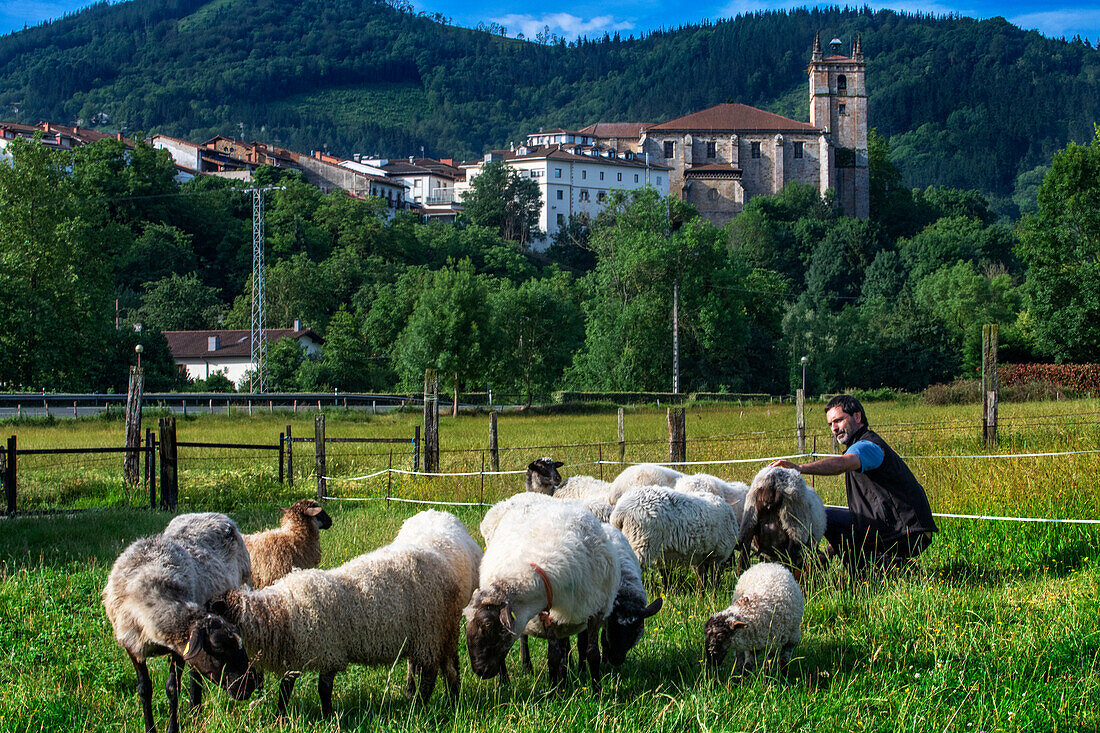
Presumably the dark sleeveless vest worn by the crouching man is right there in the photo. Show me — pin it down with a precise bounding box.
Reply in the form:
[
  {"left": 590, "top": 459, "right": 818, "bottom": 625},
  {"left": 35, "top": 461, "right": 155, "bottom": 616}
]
[{"left": 844, "top": 426, "right": 936, "bottom": 541}]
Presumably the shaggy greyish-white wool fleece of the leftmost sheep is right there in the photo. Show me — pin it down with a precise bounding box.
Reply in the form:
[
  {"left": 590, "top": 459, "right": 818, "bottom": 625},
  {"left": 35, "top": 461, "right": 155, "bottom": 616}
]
[{"left": 102, "top": 513, "right": 251, "bottom": 660}]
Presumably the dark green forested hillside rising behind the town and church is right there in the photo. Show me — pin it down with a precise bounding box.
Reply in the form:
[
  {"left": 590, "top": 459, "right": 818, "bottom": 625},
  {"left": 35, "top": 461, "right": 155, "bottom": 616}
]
[{"left": 0, "top": 0, "right": 1100, "bottom": 215}]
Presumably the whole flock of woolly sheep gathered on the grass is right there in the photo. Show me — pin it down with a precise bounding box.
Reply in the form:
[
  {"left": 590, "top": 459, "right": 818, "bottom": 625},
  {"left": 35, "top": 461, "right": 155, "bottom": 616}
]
[{"left": 103, "top": 458, "right": 825, "bottom": 733}]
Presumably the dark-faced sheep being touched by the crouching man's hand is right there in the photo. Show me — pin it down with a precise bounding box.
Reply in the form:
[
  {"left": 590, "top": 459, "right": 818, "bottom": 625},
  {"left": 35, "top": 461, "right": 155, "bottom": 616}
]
[{"left": 738, "top": 467, "right": 825, "bottom": 569}]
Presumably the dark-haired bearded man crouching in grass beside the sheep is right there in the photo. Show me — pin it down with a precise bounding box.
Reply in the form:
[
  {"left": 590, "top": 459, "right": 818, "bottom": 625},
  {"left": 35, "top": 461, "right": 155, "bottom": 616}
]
[{"left": 771, "top": 394, "right": 936, "bottom": 566}]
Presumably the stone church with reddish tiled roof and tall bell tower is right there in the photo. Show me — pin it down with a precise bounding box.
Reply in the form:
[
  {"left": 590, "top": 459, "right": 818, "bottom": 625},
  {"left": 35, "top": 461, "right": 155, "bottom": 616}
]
[{"left": 578, "top": 37, "right": 869, "bottom": 226}]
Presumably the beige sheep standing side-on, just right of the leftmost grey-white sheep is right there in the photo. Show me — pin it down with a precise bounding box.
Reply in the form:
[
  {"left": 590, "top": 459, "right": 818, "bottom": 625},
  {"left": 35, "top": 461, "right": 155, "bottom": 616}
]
[{"left": 210, "top": 544, "right": 465, "bottom": 718}]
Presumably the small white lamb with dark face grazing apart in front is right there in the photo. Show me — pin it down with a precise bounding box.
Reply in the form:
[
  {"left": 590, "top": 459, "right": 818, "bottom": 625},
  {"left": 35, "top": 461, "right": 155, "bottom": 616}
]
[{"left": 703, "top": 562, "right": 805, "bottom": 674}]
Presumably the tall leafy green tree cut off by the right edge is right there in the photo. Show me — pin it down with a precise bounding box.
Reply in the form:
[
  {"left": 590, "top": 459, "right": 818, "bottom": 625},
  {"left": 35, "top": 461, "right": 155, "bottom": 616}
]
[{"left": 1016, "top": 125, "right": 1100, "bottom": 362}]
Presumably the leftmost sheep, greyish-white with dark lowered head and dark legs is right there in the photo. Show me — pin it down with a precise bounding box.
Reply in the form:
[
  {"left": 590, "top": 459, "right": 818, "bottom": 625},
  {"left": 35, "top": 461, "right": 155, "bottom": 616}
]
[{"left": 102, "top": 513, "right": 257, "bottom": 733}]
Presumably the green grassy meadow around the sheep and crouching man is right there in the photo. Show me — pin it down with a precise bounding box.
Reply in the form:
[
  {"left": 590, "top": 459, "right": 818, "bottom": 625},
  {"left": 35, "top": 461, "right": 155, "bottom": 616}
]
[{"left": 0, "top": 400, "right": 1100, "bottom": 733}]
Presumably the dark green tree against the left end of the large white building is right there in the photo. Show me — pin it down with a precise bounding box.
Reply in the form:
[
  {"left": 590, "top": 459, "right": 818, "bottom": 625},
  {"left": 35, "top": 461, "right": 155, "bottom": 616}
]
[{"left": 462, "top": 161, "right": 542, "bottom": 249}]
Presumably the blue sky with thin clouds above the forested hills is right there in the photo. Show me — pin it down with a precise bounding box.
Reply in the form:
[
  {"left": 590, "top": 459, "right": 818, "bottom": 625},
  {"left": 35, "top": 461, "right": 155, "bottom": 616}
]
[{"left": 0, "top": 0, "right": 1100, "bottom": 40}]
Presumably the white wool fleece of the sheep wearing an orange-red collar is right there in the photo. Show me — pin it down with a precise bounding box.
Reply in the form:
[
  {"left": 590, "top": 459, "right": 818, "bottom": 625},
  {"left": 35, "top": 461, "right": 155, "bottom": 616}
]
[{"left": 477, "top": 497, "right": 619, "bottom": 638}]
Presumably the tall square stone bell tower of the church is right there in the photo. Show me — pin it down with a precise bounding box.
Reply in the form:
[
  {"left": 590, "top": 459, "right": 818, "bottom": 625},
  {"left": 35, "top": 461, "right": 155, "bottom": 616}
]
[{"left": 810, "top": 33, "right": 870, "bottom": 219}]
